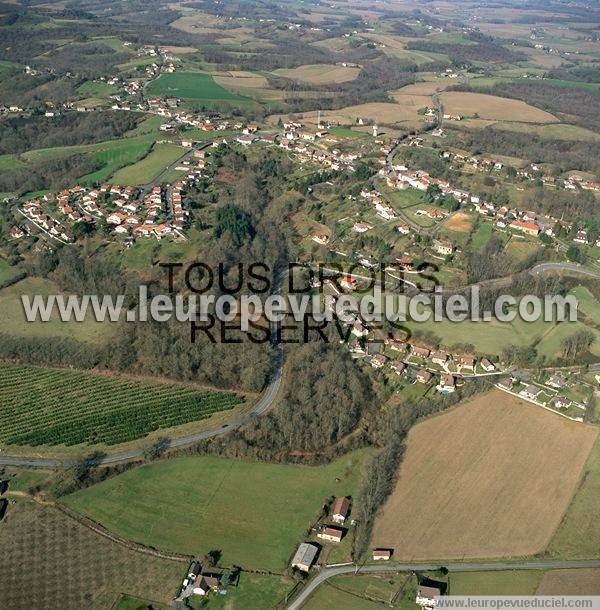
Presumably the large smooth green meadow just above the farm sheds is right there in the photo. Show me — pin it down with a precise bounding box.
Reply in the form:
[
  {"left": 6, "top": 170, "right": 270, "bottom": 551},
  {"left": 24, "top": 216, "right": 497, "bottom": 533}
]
[{"left": 64, "top": 451, "right": 367, "bottom": 572}]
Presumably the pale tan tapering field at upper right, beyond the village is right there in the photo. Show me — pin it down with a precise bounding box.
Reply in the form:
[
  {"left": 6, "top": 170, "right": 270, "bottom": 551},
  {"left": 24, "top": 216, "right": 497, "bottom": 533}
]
[{"left": 440, "top": 91, "right": 558, "bottom": 123}]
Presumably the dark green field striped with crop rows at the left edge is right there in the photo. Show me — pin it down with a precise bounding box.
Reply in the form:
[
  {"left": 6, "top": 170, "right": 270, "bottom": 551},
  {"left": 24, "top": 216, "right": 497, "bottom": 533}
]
[{"left": 0, "top": 363, "right": 243, "bottom": 446}]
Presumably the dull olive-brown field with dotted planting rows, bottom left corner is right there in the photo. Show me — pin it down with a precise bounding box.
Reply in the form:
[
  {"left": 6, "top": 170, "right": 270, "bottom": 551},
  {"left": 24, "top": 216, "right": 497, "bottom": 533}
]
[{"left": 0, "top": 501, "right": 186, "bottom": 610}]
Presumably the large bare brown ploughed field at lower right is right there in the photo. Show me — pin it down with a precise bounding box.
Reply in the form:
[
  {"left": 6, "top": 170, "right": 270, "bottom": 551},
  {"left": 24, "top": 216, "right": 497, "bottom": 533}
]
[{"left": 372, "top": 390, "right": 598, "bottom": 560}]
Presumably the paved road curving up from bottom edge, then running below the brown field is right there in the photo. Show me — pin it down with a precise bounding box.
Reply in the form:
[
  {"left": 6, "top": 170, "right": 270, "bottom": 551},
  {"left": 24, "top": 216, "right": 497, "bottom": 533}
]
[{"left": 287, "top": 560, "right": 600, "bottom": 610}]
